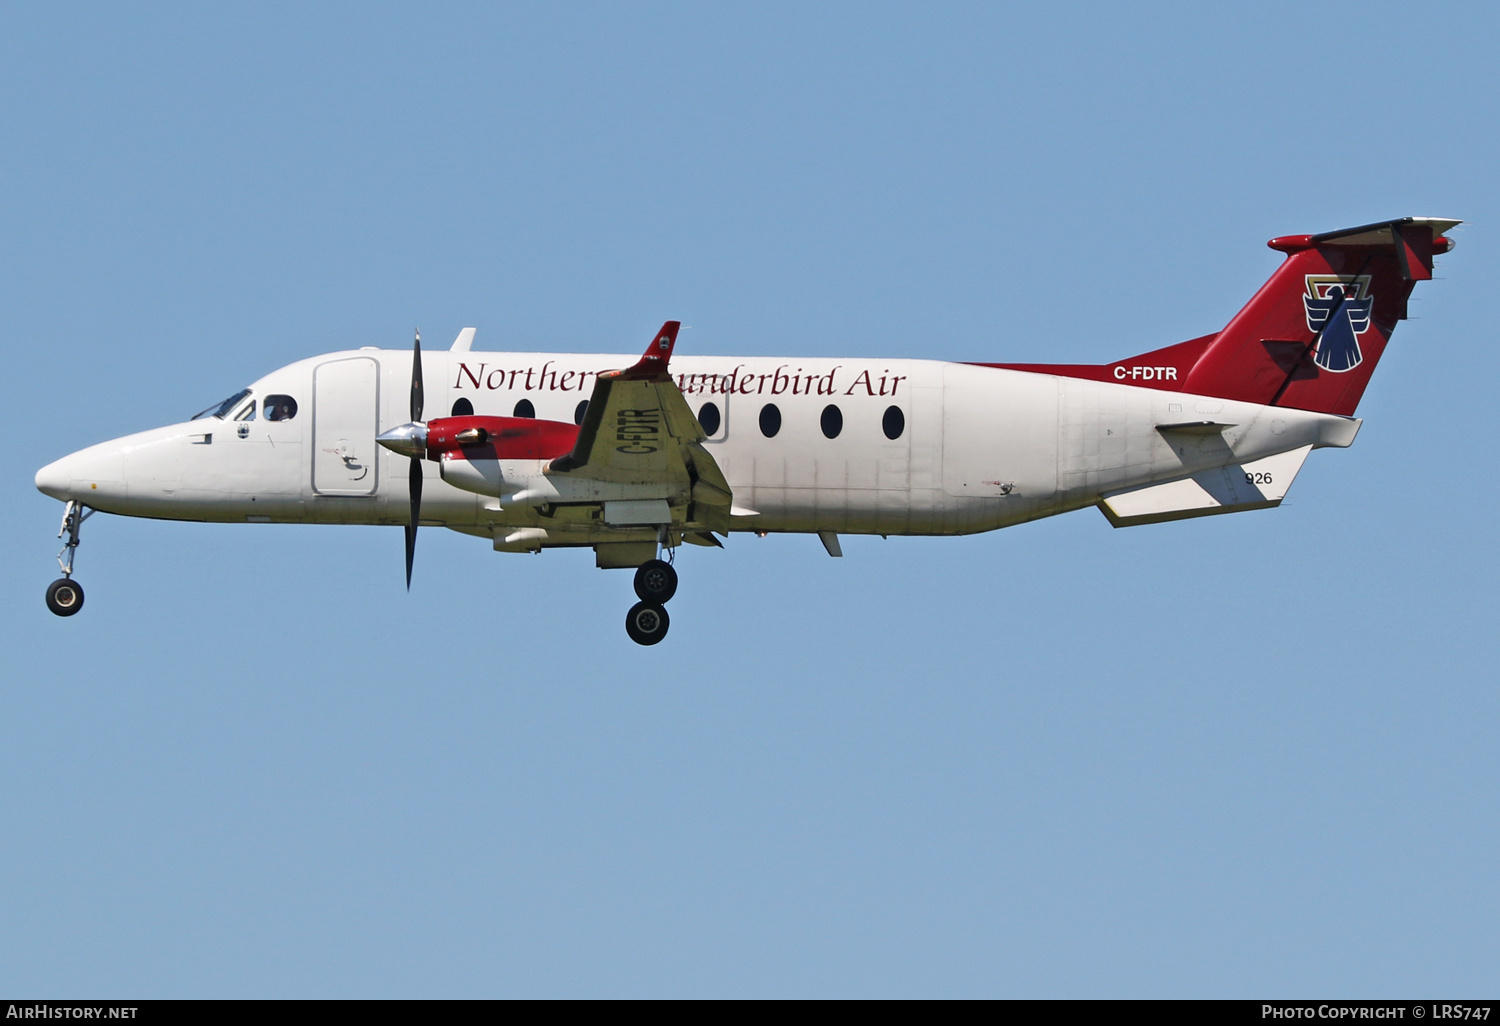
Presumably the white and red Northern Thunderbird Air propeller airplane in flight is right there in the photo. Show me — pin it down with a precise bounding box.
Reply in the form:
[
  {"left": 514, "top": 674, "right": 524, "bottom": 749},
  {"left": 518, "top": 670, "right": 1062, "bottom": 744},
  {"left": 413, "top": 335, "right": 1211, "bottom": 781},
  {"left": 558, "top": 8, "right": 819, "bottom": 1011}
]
[{"left": 36, "top": 218, "right": 1461, "bottom": 645}]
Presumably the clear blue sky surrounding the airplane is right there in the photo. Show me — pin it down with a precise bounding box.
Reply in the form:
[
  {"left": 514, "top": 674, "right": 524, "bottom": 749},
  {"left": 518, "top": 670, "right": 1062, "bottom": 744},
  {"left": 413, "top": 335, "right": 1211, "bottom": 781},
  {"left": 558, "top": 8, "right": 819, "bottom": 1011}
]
[{"left": 0, "top": 3, "right": 1500, "bottom": 998}]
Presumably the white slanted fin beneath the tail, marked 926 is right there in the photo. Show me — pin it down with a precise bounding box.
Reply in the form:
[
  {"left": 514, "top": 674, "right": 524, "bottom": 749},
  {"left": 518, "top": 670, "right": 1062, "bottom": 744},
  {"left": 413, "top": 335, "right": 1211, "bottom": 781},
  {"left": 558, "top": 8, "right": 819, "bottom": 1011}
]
[{"left": 1100, "top": 446, "right": 1313, "bottom": 527}]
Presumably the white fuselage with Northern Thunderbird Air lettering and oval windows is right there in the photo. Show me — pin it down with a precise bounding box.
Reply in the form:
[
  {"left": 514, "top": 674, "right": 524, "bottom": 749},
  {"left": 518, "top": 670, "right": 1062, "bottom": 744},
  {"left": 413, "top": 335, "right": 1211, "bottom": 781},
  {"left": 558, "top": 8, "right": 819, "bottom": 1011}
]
[{"left": 38, "top": 350, "right": 1358, "bottom": 540}]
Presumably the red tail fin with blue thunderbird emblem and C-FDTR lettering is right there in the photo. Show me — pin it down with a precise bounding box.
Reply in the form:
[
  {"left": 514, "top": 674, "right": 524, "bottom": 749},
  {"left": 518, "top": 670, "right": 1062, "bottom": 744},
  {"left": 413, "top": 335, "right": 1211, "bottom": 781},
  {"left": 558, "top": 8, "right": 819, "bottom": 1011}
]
[{"left": 992, "top": 218, "right": 1460, "bottom": 417}]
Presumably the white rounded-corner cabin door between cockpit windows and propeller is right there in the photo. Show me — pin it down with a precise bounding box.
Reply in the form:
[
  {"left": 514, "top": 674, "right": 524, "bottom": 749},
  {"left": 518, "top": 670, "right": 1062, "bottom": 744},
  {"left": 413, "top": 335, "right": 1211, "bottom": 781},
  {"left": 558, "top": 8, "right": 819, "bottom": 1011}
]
[{"left": 312, "top": 357, "right": 380, "bottom": 495}]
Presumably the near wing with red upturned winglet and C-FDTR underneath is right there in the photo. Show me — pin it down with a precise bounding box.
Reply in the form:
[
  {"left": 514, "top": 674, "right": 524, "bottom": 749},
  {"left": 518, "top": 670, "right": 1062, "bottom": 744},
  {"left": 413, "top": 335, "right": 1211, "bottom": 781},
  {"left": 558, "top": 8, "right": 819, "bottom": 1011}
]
[{"left": 548, "top": 321, "right": 734, "bottom": 534}]
